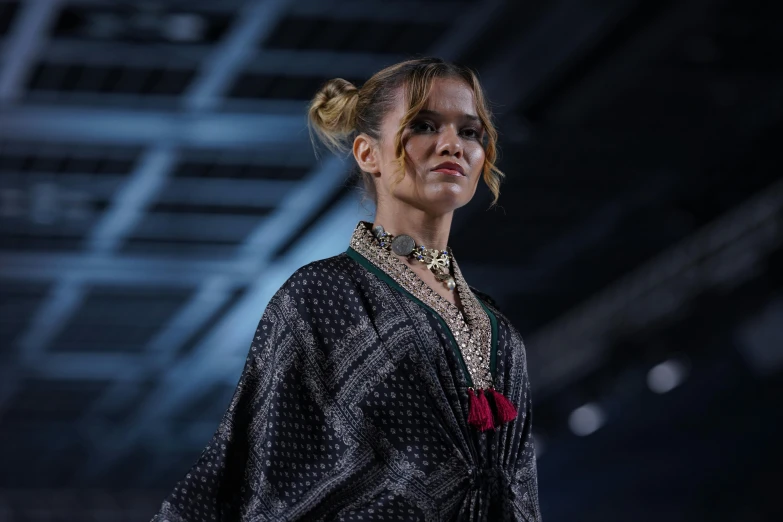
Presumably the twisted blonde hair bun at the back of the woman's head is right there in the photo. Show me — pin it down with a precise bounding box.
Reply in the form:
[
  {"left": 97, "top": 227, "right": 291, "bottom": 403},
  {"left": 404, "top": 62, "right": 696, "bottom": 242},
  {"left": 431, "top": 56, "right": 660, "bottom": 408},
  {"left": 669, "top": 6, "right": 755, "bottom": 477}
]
[{"left": 307, "top": 78, "right": 359, "bottom": 151}]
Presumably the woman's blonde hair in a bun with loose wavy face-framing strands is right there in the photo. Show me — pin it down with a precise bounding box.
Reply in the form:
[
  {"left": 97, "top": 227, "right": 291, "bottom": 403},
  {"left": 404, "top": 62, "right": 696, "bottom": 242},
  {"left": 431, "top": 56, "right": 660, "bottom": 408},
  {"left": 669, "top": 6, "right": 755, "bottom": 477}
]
[{"left": 308, "top": 58, "right": 505, "bottom": 205}]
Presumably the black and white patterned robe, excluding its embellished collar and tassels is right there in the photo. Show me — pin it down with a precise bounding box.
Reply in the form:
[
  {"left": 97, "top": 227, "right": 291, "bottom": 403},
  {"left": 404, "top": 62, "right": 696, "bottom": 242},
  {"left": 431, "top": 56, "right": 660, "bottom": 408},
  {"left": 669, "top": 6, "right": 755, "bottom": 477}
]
[{"left": 152, "top": 220, "right": 541, "bottom": 522}]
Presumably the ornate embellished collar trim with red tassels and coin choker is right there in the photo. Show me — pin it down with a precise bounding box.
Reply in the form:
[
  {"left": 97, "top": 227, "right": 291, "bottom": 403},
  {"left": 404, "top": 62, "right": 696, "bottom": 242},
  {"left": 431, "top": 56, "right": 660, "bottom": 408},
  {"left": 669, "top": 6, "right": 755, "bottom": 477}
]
[{"left": 351, "top": 222, "right": 517, "bottom": 431}]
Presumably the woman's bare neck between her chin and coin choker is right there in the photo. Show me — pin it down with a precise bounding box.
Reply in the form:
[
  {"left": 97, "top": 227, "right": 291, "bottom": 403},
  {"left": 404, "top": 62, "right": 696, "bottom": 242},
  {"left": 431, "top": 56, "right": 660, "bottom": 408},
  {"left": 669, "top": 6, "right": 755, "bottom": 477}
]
[{"left": 373, "top": 202, "right": 454, "bottom": 250}]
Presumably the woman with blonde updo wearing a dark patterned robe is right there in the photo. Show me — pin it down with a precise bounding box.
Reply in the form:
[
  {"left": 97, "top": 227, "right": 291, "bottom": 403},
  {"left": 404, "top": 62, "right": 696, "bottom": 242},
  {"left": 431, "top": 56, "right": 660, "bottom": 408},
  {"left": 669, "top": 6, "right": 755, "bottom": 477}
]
[{"left": 153, "top": 59, "right": 541, "bottom": 522}]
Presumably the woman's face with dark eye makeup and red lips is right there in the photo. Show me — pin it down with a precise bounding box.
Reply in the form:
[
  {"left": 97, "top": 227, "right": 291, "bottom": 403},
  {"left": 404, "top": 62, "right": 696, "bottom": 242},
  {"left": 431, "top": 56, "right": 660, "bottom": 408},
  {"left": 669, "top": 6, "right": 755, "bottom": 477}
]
[{"left": 376, "top": 78, "right": 484, "bottom": 215}]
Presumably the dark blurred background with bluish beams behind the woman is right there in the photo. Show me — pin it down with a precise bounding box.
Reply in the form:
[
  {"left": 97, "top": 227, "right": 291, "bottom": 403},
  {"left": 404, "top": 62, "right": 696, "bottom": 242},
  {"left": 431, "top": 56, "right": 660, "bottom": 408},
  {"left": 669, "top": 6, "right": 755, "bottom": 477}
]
[{"left": 0, "top": 0, "right": 783, "bottom": 522}]
